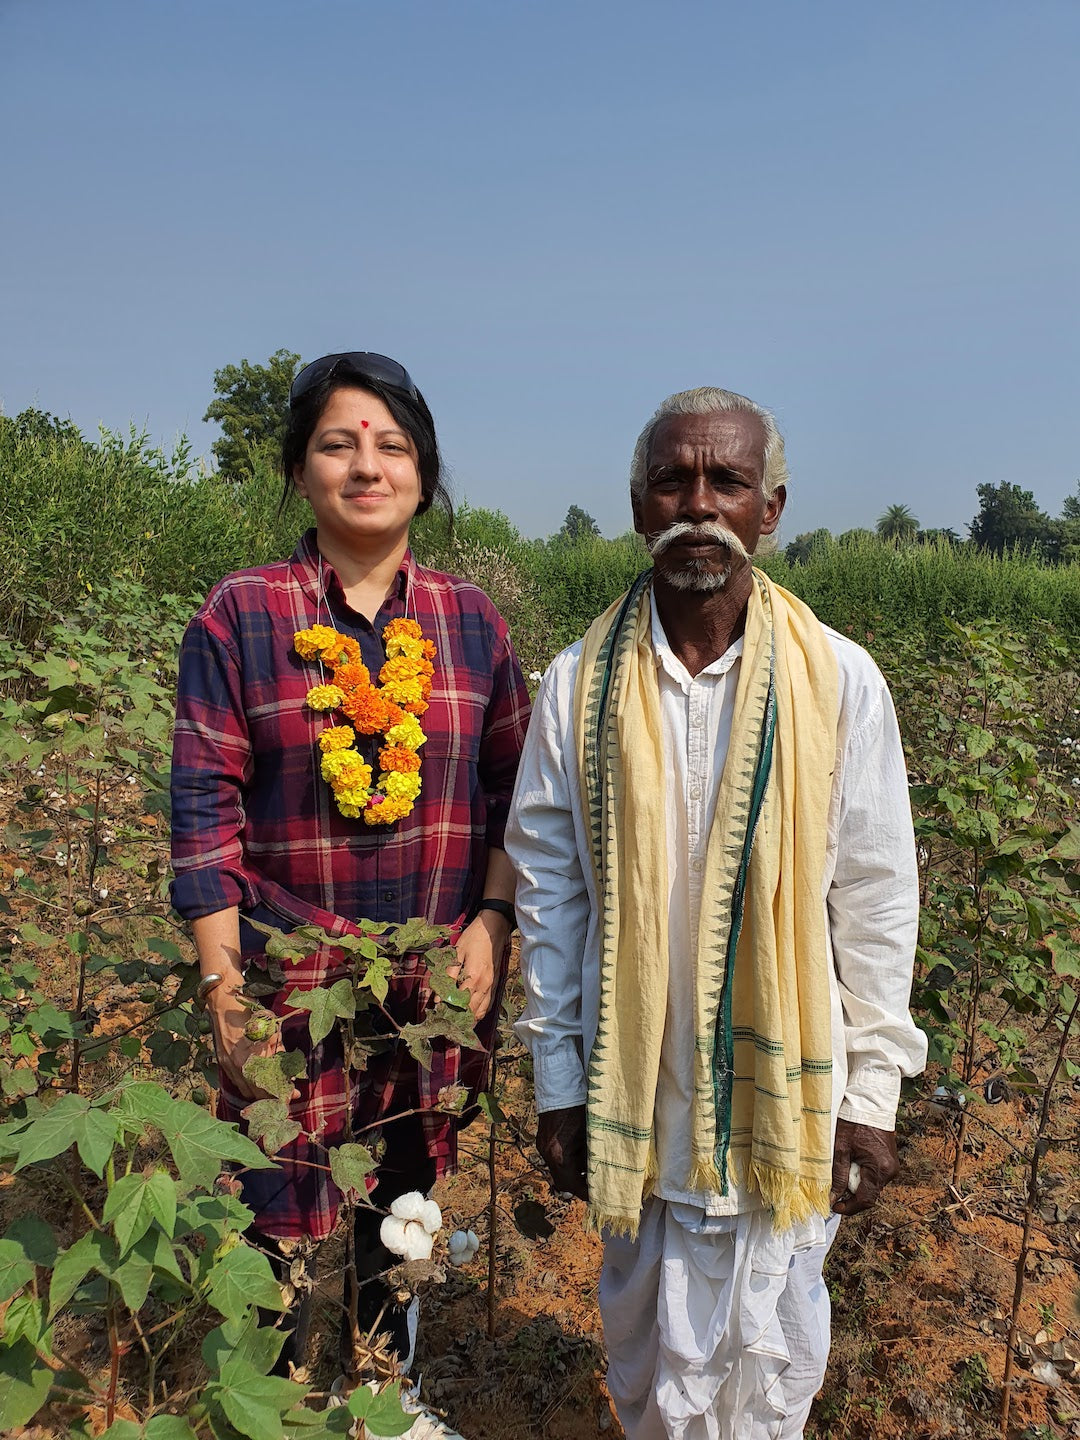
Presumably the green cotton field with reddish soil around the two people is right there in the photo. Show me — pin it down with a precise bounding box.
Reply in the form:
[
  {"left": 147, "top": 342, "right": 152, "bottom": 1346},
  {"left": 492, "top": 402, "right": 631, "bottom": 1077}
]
[{"left": 0, "top": 411, "right": 1080, "bottom": 1440}]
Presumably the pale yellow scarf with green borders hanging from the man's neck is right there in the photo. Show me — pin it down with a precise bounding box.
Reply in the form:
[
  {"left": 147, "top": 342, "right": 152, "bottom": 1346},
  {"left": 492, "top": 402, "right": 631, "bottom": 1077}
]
[{"left": 575, "top": 570, "right": 838, "bottom": 1236}]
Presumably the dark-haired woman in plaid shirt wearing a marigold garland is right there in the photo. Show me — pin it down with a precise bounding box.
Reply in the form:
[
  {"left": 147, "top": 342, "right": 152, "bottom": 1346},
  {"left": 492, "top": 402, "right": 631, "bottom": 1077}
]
[{"left": 173, "top": 351, "right": 528, "bottom": 1393}]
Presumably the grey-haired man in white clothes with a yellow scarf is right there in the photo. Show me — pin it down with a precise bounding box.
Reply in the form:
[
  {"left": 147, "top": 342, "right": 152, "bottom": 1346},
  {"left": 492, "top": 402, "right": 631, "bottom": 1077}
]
[{"left": 507, "top": 389, "right": 926, "bottom": 1440}]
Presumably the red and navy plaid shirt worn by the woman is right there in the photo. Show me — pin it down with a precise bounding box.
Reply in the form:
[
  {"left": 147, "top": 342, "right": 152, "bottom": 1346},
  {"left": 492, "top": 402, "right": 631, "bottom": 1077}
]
[{"left": 173, "top": 530, "right": 528, "bottom": 1238}]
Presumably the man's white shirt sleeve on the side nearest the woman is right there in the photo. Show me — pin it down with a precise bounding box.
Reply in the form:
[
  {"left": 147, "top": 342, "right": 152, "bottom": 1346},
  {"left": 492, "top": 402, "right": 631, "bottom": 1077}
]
[{"left": 505, "top": 652, "right": 590, "bottom": 1112}]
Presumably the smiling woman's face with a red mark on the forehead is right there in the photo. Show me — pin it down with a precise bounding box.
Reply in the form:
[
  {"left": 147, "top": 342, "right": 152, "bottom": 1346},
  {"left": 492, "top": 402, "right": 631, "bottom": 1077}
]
[{"left": 292, "top": 386, "right": 420, "bottom": 553}]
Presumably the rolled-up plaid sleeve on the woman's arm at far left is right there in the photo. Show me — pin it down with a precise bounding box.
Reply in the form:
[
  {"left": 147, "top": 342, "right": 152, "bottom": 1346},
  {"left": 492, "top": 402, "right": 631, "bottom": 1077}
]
[{"left": 171, "top": 612, "right": 255, "bottom": 920}]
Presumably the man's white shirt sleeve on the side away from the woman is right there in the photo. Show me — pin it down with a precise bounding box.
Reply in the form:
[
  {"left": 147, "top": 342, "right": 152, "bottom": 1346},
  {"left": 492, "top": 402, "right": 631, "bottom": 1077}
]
[{"left": 828, "top": 668, "right": 926, "bottom": 1130}]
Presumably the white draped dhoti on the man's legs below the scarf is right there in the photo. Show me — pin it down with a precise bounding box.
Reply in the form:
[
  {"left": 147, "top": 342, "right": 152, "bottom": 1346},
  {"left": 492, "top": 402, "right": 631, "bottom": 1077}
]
[{"left": 599, "top": 1198, "right": 840, "bottom": 1440}]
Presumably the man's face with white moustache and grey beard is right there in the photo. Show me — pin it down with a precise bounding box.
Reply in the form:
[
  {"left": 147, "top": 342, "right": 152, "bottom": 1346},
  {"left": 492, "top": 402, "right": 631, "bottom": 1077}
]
[{"left": 634, "top": 410, "right": 786, "bottom": 590}]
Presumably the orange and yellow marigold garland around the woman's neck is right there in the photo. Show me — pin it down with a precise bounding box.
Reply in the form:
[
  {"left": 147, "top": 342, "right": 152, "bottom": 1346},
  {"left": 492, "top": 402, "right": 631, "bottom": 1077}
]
[{"left": 292, "top": 619, "right": 435, "bottom": 825}]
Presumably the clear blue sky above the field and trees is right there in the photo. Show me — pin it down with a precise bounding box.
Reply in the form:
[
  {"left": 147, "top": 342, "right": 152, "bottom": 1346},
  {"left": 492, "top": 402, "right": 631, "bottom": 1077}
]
[{"left": 0, "top": 0, "right": 1080, "bottom": 539}]
